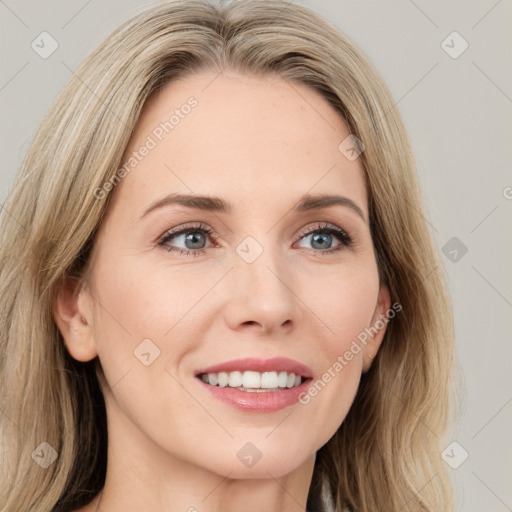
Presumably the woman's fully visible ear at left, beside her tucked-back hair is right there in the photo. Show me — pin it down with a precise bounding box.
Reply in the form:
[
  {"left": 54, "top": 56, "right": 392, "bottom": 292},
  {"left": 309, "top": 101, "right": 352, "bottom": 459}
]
[{"left": 53, "top": 277, "right": 98, "bottom": 362}]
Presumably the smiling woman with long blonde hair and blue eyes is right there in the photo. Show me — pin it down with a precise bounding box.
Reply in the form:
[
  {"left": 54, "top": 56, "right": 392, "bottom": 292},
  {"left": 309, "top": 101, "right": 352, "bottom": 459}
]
[{"left": 0, "top": 0, "right": 462, "bottom": 512}]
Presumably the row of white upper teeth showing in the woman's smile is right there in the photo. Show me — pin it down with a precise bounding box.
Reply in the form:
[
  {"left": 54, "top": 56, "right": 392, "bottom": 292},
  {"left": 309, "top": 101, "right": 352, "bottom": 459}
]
[{"left": 201, "top": 371, "right": 302, "bottom": 391}]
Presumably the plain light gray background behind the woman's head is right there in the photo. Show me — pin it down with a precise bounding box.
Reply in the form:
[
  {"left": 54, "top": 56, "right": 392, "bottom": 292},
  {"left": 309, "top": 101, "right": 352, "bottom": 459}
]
[{"left": 0, "top": 0, "right": 512, "bottom": 512}]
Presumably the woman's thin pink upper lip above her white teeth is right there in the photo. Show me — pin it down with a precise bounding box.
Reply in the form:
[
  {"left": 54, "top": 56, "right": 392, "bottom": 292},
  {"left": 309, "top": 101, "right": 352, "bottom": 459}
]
[{"left": 196, "top": 357, "right": 312, "bottom": 379}]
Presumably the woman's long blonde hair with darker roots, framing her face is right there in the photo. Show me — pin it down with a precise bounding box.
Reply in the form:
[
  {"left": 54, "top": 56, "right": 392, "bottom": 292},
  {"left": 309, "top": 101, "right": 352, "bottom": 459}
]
[{"left": 0, "top": 0, "right": 464, "bottom": 512}]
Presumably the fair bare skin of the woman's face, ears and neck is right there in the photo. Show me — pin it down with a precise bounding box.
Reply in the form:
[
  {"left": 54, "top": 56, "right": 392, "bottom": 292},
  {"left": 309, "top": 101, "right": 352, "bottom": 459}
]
[{"left": 54, "top": 71, "right": 390, "bottom": 512}]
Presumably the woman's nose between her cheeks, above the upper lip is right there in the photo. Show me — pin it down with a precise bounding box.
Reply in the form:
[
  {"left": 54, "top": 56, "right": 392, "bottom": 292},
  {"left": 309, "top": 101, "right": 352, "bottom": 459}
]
[{"left": 224, "top": 244, "right": 300, "bottom": 335}]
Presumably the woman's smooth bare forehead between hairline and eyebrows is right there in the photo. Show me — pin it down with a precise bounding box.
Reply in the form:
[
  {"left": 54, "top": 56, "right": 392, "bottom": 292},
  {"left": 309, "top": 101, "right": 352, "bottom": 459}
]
[{"left": 109, "top": 72, "right": 367, "bottom": 222}]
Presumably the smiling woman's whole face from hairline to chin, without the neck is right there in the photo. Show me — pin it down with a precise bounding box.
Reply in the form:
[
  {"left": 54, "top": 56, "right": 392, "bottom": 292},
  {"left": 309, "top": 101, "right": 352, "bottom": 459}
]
[{"left": 59, "top": 72, "right": 389, "bottom": 479}]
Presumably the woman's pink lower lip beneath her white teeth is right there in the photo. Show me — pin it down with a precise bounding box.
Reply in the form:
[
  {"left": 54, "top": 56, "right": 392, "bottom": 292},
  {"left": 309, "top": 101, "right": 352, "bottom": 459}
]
[{"left": 198, "top": 379, "right": 313, "bottom": 412}]
